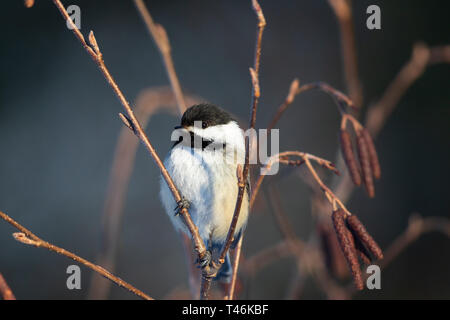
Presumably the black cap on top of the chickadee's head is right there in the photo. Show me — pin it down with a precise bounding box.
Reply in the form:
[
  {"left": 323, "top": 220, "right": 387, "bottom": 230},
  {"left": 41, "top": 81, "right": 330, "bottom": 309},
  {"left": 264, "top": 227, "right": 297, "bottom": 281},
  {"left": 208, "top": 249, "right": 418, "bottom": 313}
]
[{"left": 181, "top": 103, "right": 233, "bottom": 128}]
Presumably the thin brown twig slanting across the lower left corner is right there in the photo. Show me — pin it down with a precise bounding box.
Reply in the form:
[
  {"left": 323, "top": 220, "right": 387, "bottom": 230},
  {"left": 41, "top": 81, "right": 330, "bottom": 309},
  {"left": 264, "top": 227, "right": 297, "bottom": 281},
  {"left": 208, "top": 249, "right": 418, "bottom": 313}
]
[{"left": 0, "top": 211, "right": 153, "bottom": 300}]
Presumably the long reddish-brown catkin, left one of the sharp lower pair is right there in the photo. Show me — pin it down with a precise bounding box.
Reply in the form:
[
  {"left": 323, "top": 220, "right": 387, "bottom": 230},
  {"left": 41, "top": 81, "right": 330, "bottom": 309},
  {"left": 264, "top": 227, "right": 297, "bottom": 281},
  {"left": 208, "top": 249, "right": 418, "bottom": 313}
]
[{"left": 331, "top": 209, "right": 364, "bottom": 290}]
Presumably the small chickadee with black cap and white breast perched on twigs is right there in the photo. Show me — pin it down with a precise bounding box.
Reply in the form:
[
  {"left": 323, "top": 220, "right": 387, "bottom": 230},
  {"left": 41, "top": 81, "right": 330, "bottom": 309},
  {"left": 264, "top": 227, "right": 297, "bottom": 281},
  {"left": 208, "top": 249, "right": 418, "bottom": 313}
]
[{"left": 160, "top": 103, "right": 250, "bottom": 283}]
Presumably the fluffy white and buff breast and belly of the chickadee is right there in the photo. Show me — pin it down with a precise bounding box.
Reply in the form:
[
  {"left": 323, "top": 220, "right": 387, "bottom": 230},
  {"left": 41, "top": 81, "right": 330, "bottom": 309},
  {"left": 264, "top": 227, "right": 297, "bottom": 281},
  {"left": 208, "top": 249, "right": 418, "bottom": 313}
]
[{"left": 161, "top": 126, "right": 248, "bottom": 243}]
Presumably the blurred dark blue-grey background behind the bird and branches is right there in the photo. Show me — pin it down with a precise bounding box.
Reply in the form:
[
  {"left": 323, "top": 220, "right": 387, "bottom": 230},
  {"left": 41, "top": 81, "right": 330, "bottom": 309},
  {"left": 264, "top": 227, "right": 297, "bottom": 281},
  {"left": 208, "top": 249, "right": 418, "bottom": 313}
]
[{"left": 0, "top": 0, "right": 450, "bottom": 299}]
